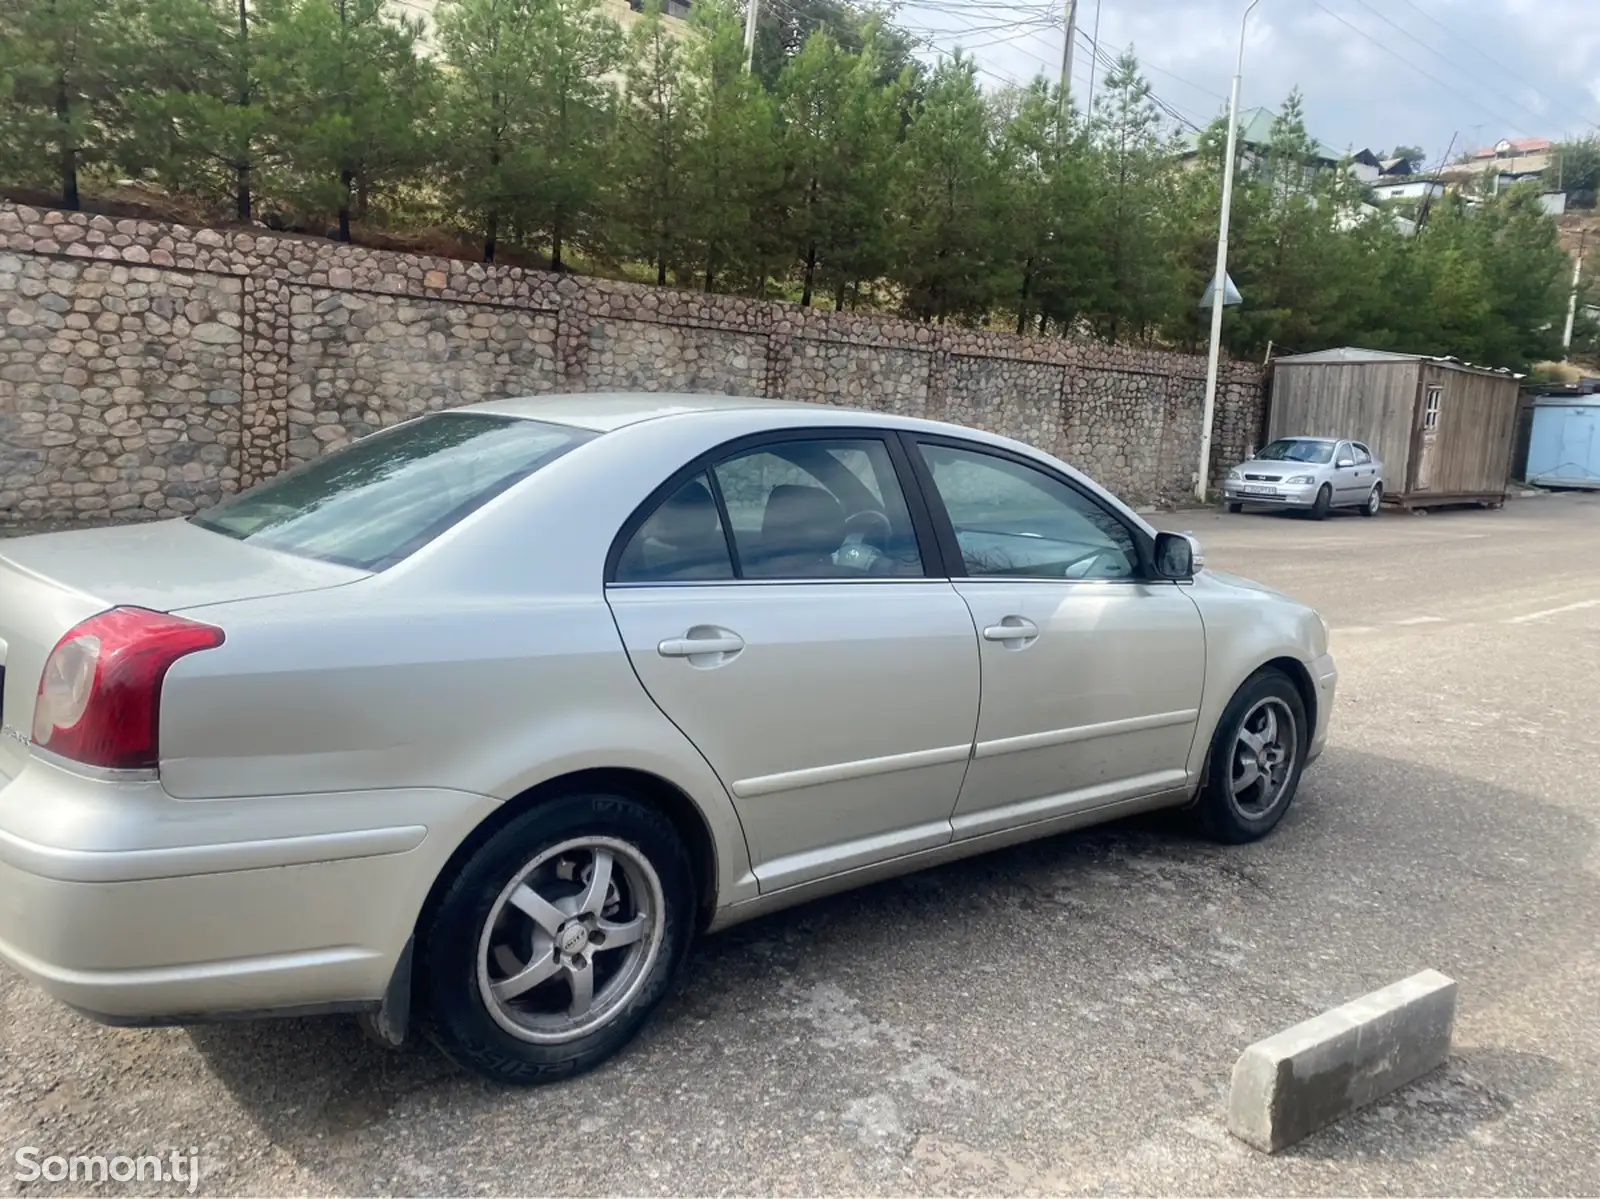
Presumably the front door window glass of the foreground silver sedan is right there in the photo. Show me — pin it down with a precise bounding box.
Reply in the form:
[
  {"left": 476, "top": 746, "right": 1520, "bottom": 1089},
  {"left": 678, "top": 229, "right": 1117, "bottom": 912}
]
[{"left": 922, "top": 445, "right": 1139, "bottom": 579}]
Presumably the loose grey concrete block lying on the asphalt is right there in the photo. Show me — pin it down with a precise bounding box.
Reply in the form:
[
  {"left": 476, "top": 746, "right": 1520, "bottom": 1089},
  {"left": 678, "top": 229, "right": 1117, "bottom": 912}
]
[{"left": 1227, "top": 970, "right": 1456, "bottom": 1153}]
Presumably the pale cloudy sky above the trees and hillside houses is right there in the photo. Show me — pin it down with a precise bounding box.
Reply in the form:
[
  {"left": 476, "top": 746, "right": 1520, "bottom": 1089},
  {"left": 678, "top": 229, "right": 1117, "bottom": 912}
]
[{"left": 896, "top": 0, "right": 1600, "bottom": 163}]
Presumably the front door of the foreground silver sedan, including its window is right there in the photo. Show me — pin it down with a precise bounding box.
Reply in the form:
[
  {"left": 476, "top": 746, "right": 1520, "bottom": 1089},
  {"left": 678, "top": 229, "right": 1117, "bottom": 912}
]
[{"left": 915, "top": 439, "right": 1205, "bottom": 837}]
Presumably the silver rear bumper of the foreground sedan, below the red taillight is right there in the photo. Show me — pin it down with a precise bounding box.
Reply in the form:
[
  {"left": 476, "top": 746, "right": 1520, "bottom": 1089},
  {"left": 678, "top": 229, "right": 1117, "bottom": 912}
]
[{"left": 0, "top": 759, "right": 496, "bottom": 1023}]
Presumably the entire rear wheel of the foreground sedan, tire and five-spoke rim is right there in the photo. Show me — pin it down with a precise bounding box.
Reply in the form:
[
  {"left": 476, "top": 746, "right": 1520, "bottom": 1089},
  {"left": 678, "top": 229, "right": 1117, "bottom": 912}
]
[{"left": 418, "top": 796, "right": 694, "bottom": 1085}]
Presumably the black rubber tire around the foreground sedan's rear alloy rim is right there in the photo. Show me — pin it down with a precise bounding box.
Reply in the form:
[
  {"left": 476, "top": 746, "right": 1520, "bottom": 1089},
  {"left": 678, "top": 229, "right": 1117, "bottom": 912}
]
[{"left": 416, "top": 794, "right": 696, "bottom": 1085}]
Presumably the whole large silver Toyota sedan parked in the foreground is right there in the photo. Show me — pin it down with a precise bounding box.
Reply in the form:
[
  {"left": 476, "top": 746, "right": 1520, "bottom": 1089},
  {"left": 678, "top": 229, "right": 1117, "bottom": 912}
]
[{"left": 0, "top": 395, "right": 1336, "bottom": 1082}]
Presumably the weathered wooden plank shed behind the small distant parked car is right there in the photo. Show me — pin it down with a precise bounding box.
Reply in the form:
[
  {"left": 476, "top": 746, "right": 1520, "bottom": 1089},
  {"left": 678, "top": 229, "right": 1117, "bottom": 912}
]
[{"left": 1267, "top": 347, "right": 1520, "bottom": 507}]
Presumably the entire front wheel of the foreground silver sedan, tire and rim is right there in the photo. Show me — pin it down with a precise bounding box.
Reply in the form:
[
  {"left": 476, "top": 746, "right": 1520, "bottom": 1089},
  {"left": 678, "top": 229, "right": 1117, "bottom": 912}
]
[{"left": 1194, "top": 668, "right": 1310, "bottom": 845}]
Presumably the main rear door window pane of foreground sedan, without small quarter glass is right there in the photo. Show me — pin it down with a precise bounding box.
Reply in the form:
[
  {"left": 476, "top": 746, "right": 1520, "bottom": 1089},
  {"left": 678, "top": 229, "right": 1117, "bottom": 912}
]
[{"left": 714, "top": 439, "right": 923, "bottom": 579}]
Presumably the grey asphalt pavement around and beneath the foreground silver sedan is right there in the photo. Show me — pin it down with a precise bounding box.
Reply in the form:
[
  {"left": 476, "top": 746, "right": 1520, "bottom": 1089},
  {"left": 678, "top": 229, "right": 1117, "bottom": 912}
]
[{"left": 0, "top": 496, "right": 1600, "bottom": 1194}]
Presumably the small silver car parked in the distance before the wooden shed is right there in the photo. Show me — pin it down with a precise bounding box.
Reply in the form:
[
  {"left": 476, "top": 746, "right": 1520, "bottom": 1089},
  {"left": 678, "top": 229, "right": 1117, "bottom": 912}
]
[{"left": 1222, "top": 437, "right": 1384, "bottom": 520}]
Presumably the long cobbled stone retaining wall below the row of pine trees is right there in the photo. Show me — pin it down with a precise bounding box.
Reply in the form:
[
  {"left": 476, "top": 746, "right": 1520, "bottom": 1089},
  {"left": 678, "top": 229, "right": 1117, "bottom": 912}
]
[{"left": 0, "top": 203, "right": 1262, "bottom": 520}]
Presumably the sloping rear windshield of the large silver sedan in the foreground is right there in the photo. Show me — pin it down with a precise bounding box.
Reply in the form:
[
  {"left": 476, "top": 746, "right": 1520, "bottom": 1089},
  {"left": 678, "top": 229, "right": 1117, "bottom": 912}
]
[{"left": 190, "top": 413, "right": 595, "bottom": 570}]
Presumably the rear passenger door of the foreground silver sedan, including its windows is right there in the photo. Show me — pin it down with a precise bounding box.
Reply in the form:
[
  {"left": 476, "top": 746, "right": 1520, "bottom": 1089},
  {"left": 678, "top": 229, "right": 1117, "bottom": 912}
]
[{"left": 606, "top": 431, "right": 978, "bottom": 892}]
